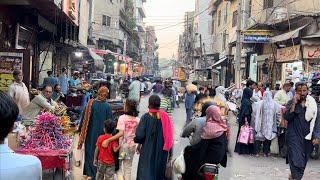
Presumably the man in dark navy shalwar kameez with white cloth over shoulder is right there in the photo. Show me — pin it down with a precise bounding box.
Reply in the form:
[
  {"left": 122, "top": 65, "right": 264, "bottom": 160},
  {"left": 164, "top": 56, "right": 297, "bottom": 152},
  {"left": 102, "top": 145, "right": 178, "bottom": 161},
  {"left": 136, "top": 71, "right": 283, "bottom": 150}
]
[{"left": 284, "top": 83, "right": 319, "bottom": 180}]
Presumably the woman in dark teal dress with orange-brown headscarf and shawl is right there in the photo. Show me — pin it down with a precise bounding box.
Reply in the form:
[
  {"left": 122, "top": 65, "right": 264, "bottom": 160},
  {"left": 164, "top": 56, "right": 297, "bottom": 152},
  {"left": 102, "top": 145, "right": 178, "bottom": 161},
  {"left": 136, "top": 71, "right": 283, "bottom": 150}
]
[{"left": 78, "top": 86, "right": 112, "bottom": 179}]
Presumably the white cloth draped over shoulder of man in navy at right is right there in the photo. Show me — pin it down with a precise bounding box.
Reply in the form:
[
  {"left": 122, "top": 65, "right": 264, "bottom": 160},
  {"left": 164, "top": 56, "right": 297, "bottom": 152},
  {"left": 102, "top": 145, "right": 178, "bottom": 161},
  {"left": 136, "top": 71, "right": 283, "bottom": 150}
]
[{"left": 305, "top": 95, "right": 318, "bottom": 140}]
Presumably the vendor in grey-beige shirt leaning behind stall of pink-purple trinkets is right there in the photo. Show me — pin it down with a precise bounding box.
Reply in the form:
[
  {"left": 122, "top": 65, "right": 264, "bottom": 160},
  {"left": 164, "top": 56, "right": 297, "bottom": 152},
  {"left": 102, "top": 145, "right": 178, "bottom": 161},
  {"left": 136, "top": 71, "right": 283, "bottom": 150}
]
[{"left": 22, "top": 85, "right": 57, "bottom": 120}]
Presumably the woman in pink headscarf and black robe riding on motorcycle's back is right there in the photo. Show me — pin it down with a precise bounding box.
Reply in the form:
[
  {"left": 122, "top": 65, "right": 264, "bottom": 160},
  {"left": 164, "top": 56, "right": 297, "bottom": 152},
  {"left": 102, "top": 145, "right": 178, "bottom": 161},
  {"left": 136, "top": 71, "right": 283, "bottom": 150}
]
[{"left": 182, "top": 105, "right": 228, "bottom": 180}]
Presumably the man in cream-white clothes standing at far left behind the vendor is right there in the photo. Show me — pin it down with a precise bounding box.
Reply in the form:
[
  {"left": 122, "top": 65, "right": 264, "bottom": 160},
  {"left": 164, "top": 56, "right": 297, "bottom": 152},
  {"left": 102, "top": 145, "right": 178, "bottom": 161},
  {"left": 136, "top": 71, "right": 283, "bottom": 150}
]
[{"left": 8, "top": 70, "right": 30, "bottom": 114}]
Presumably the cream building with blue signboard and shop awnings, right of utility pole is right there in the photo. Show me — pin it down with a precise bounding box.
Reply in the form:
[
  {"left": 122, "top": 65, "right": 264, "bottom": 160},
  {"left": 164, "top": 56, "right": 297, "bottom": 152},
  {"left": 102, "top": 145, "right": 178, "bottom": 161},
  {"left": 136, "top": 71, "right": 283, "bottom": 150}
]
[{"left": 243, "top": 0, "right": 320, "bottom": 84}]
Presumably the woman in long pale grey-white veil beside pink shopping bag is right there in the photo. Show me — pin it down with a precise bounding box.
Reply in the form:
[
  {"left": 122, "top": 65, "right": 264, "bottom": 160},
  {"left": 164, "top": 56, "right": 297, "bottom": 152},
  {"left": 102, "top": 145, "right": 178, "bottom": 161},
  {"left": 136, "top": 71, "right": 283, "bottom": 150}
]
[{"left": 253, "top": 91, "right": 281, "bottom": 156}]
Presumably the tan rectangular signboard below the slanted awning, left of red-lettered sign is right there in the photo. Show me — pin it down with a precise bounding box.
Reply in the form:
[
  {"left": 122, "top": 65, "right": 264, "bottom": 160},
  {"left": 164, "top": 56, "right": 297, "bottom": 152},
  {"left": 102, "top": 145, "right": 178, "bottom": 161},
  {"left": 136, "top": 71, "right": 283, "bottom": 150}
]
[{"left": 276, "top": 45, "right": 301, "bottom": 63}]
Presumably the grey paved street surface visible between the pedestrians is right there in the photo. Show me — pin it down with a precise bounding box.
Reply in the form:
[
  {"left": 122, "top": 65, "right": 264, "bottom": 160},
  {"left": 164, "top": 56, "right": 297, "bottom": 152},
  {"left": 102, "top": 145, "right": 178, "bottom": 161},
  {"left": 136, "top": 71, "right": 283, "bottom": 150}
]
[{"left": 48, "top": 95, "right": 320, "bottom": 180}]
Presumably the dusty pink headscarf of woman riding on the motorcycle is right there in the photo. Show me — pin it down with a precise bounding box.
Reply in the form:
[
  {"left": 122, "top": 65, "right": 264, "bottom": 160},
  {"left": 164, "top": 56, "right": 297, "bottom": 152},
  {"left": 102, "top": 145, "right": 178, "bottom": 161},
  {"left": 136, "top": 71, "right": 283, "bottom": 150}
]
[{"left": 201, "top": 105, "right": 228, "bottom": 139}]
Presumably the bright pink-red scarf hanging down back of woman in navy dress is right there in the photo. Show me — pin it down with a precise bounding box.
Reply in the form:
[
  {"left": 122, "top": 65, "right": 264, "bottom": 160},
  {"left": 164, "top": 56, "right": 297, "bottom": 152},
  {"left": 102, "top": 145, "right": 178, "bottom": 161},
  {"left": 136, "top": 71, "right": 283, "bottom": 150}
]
[{"left": 149, "top": 109, "right": 173, "bottom": 151}]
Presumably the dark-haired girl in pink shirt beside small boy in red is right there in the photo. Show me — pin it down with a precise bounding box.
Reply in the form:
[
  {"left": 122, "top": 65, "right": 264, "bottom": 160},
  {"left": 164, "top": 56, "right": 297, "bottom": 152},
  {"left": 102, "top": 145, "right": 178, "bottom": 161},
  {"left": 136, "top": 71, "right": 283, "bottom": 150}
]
[{"left": 103, "top": 100, "right": 140, "bottom": 179}]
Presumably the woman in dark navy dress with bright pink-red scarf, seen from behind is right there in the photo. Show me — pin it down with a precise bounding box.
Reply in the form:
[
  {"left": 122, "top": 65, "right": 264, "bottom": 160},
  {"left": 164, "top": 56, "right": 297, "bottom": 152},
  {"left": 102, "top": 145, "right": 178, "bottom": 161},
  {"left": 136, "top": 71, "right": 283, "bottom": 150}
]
[{"left": 134, "top": 95, "right": 173, "bottom": 180}]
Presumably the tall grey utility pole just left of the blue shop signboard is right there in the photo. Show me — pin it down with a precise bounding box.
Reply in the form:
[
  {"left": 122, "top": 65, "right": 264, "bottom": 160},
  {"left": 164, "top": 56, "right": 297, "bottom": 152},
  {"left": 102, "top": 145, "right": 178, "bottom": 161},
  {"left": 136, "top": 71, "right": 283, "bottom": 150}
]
[{"left": 235, "top": 0, "right": 242, "bottom": 88}]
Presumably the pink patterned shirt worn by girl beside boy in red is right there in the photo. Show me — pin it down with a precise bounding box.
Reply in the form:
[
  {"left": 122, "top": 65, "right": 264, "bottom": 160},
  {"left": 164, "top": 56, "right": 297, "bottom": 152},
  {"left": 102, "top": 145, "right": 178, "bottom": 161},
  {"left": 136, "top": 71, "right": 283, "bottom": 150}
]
[{"left": 117, "top": 115, "right": 140, "bottom": 148}]
